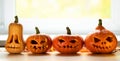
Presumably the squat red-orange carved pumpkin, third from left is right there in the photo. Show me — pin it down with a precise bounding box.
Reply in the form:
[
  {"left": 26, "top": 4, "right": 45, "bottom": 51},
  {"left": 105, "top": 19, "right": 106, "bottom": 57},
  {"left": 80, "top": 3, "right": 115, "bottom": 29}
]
[{"left": 53, "top": 27, "right": 83, "bottom": 54}]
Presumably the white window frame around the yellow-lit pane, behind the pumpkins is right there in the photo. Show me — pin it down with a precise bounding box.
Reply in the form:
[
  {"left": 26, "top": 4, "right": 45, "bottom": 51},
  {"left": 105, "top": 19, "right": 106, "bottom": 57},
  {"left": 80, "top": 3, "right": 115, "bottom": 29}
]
[{"left": 0, "top": 0, "right": 120, "bottom": 35}]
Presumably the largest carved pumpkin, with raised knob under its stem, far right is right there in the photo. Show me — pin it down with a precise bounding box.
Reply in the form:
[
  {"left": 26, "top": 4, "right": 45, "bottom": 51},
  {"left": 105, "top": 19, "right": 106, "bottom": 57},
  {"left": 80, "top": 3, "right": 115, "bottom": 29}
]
[{"left": 85, "top": 19, "right": 117, "bottom": 53}]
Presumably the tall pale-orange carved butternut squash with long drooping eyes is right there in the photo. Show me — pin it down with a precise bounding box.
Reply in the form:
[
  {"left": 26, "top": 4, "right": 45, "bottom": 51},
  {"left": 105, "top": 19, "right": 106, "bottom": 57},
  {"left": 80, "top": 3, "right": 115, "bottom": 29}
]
[{"left": 5, "top": 16, "right": 25, "bottom": 53}]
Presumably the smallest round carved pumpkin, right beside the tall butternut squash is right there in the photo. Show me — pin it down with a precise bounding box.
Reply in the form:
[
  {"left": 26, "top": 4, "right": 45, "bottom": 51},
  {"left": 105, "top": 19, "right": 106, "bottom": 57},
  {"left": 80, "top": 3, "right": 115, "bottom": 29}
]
[{"left": 26, "top": 27, "right": 52, "bottom": 53}]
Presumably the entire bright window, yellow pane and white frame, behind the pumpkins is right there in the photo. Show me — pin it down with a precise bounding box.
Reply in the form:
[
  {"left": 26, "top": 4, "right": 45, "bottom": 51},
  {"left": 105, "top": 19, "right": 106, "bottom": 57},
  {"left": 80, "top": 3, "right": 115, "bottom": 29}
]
[{"left": 0, "top": 0, "right": 120, "bottom": 34}]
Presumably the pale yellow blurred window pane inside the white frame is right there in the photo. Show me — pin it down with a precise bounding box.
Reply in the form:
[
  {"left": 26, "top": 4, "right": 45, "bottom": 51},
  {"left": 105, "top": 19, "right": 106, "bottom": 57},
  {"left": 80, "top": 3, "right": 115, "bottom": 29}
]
[{"left": 16, "top": 0, "right": 110, "bottom": 19}]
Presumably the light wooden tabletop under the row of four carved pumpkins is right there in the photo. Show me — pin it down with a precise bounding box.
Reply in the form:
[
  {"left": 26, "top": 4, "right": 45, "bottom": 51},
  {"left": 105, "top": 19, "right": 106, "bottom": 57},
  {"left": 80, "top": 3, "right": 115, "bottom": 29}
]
[{"left": 0, "top": 48, "right": 120, "bottom": 61}]
